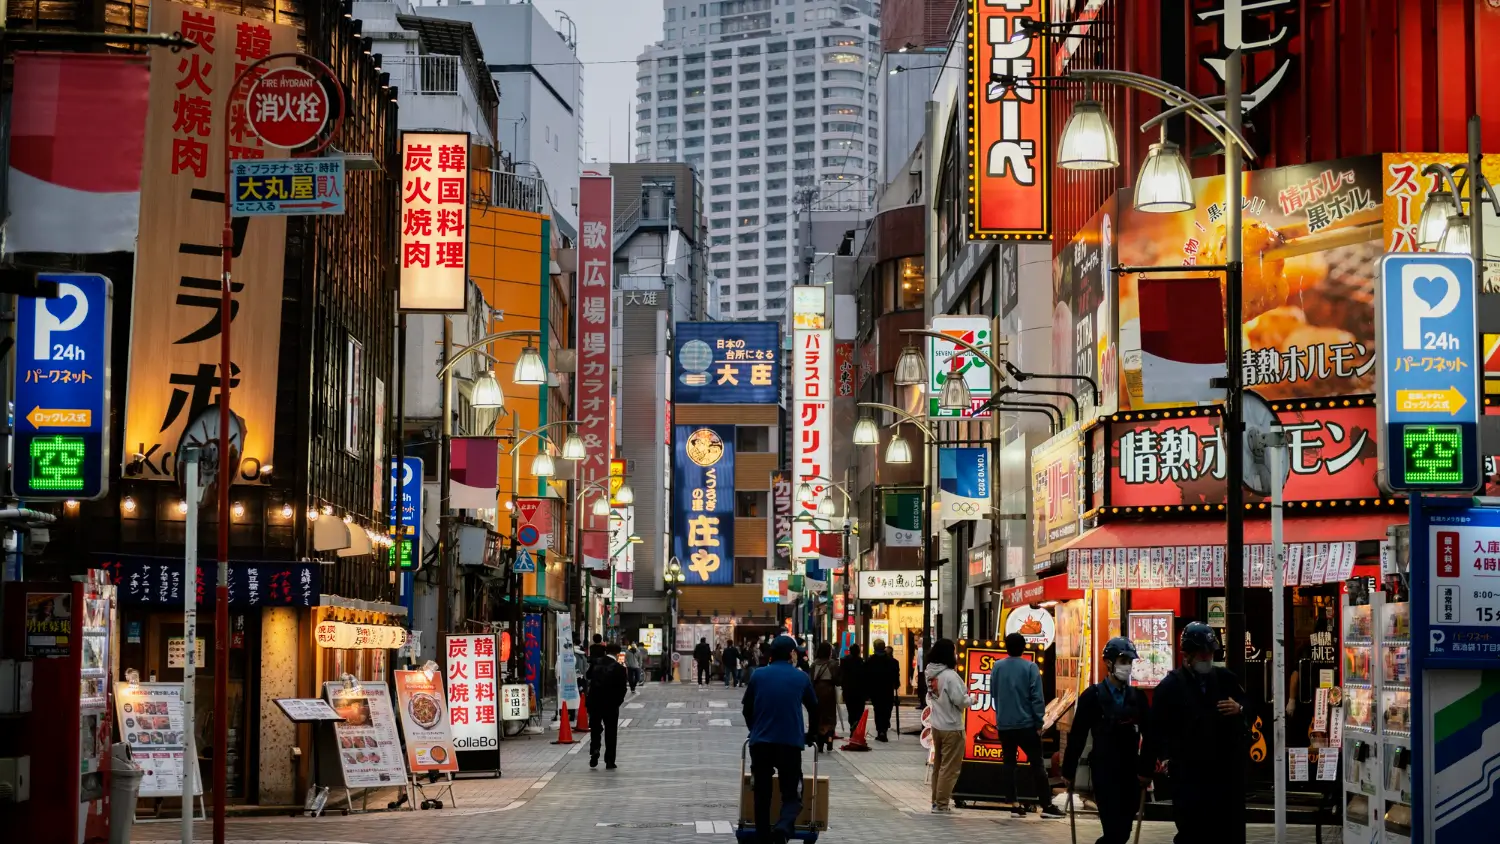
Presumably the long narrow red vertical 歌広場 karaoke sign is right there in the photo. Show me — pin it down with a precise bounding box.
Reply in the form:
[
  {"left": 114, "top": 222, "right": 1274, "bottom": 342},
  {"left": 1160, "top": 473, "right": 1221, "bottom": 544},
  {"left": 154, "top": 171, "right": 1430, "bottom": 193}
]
[{"left": 573, "top": 174, "right": 615, "bottom": 557}]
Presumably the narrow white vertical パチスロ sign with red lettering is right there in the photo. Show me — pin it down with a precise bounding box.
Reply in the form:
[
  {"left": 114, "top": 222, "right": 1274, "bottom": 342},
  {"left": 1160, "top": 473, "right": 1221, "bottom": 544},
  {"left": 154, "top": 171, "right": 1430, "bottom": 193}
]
[{"left": 792, "top": 328, "right": 834, "bottom": 559}]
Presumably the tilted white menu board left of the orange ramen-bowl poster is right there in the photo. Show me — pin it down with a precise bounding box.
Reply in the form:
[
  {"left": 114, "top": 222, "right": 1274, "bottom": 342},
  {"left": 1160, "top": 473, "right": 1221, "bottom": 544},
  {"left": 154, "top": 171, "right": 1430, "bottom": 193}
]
[{"left": 323, "top": 681, "right": 407, "bottom": 789}]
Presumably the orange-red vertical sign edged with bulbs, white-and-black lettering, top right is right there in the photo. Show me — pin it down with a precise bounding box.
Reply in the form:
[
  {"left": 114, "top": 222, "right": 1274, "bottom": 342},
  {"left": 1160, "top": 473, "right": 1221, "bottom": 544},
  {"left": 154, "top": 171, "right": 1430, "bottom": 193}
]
[{"left": 968, "top": 0, "right": 1052, "bottom": 240}]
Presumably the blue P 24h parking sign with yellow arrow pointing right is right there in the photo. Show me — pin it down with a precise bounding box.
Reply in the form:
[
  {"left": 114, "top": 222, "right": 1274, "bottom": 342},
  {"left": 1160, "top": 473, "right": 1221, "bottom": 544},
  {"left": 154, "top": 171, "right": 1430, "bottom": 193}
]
[{"left": 1376, "top": 252, "right": 1484, "bottom": 492}]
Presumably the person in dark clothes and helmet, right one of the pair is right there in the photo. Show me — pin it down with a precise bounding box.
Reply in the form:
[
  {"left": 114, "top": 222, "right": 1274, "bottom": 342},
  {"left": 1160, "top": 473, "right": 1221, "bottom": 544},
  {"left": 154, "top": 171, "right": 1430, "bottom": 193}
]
[{"left": 1142, "top": 621, "right": 1250, "bottom": 844}]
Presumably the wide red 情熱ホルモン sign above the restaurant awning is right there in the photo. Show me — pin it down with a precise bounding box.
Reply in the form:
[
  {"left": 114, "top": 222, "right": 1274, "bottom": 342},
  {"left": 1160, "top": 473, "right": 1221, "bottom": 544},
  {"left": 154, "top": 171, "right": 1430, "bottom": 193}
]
[{"left": 1109, "top": 405, "right": 1380, "bottom": 507}]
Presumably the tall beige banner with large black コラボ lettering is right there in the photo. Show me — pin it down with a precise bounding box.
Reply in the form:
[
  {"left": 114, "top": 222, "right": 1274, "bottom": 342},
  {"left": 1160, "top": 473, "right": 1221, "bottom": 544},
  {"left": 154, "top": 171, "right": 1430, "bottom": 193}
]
[{"left": 122, "top": 0, "right": 297, "bottom": 481}]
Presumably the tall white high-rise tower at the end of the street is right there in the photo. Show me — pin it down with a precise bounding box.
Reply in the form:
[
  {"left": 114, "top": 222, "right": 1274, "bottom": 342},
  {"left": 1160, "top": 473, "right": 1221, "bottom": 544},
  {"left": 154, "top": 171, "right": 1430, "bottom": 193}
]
[{"left": 635, "top": 0, "right": 881, "bottom": 319}]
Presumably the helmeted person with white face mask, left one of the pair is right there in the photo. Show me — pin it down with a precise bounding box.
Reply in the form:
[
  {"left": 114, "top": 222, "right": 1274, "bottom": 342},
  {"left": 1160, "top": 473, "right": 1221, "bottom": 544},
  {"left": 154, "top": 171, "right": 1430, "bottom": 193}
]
[{"left": 1062, "top": 636, "right": 1151, "bottom": 844}]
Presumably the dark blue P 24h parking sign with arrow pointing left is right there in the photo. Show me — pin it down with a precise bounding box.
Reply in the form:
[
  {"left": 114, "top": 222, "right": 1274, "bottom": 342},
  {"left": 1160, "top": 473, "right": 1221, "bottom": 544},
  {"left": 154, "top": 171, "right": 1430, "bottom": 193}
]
[{"left": 11, "top": 273, "right": 114, "bottom": 501}]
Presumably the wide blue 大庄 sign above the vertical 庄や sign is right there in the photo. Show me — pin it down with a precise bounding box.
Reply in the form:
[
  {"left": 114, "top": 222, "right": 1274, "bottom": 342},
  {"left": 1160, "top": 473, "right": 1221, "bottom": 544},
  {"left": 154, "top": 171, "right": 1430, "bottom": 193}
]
[{"left": 672, "top": 322, "right": 780, "bottom": 405}]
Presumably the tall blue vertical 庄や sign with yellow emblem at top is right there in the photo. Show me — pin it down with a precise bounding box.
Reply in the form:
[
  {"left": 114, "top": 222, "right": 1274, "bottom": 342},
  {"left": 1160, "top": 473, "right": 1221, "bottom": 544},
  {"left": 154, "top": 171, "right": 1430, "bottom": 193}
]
[{"left": 672, "top": 424, "right": 735, "bottom": 586}]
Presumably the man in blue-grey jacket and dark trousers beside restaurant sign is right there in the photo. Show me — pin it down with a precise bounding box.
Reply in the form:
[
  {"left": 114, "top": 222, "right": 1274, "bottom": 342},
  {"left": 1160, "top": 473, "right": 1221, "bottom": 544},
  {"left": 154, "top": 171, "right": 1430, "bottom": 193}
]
[{"left": 990, "top": 633, "right": 1062, "bottom": 817}]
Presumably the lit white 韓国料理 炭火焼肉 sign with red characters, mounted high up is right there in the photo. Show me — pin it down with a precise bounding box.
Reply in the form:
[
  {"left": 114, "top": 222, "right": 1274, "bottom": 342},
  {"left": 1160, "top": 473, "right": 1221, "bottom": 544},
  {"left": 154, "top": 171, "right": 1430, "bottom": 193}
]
[{"left": 399, "top": 132, "right": 468, "bottom": 313}]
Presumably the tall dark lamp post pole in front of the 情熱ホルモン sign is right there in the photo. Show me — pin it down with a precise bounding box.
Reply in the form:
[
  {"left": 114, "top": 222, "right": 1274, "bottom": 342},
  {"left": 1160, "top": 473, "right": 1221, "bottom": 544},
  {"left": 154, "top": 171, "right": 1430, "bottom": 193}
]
[{"left": 1224, "top": 49, "right": 1248, "bottom": 680}]
